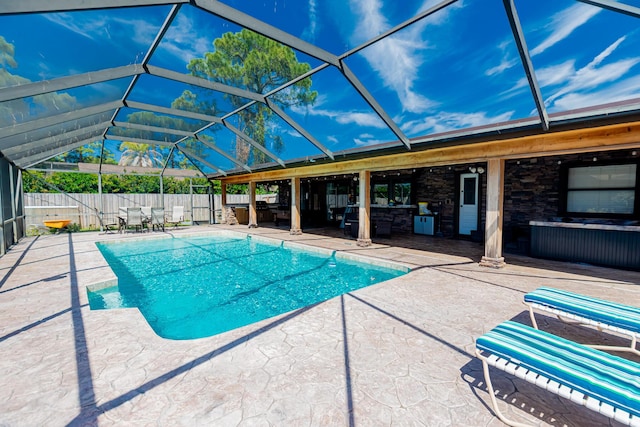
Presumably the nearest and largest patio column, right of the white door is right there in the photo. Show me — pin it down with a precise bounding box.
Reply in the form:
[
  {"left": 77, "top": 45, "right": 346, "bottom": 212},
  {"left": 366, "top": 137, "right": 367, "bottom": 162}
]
[{"left": 480, "top": 159, "right": 505, "bottom": 268}]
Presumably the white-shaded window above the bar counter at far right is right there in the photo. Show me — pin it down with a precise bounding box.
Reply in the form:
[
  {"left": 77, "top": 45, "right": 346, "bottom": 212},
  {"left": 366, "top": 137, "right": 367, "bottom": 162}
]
[{"left": 566, "top": 164, "right": 637, "bottom": 215}]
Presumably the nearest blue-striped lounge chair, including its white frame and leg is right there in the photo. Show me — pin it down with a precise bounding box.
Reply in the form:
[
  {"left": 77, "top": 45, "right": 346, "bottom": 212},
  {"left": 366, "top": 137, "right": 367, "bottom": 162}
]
[{"left": 476, "top": 321, "right": 640, "bottom": 426}]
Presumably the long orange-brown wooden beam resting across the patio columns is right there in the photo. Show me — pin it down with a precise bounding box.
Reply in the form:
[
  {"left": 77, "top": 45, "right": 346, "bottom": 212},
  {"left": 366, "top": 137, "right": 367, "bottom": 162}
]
[{"left": 216, "top": 122, "right": 640, "bottom": 184}]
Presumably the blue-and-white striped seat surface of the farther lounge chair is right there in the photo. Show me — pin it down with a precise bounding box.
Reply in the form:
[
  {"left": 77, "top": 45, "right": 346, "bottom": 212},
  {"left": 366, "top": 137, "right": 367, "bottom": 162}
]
[{"left": 524, "top": 287, "right": 640, "bottom": 334}]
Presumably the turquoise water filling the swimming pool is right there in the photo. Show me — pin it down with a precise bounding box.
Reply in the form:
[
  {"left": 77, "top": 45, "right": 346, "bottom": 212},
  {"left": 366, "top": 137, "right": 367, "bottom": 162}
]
[{"left": 89, "top": 235, "right": 406, "bottom": 339}]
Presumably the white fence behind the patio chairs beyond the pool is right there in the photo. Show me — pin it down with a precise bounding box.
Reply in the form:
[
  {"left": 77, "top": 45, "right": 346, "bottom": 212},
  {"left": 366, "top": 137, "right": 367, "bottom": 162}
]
[{"left": 24, "top": 193, "right": 277, "bottom": 230}]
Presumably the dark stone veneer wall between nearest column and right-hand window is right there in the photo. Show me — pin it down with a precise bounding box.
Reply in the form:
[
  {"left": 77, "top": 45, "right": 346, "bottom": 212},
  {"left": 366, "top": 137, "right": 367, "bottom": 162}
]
[{"left": 503, "top": 150, "right": 633, "bottom": 251}]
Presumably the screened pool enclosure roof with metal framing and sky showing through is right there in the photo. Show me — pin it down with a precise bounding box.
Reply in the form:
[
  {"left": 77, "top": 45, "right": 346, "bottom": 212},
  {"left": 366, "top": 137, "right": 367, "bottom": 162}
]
[{"left": 0, "top": 0, "right": 640, "bottom": 179}]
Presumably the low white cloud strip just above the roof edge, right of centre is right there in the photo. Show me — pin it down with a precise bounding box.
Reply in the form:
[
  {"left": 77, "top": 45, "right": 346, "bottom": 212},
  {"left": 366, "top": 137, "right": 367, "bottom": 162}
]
[{"left": 402, "top": 111, "right": 513, "bottom": 135}]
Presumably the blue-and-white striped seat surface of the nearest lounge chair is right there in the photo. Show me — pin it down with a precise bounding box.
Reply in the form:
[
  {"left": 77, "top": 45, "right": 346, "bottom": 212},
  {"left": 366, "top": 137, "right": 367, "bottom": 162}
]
[{"left": 476, "top": 321, "right": 640, "bottom": 417}]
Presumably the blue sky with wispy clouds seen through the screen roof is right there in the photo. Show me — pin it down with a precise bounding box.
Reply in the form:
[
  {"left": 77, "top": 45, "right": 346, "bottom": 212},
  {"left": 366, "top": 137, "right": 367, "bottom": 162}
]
[{"left": 0, "top": 0, "right": 640, "bottom": 172}]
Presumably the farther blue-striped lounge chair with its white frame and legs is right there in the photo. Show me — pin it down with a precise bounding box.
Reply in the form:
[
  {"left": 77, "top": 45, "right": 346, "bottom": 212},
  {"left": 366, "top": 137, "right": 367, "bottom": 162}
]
[{"left": 524, "top": 287, "right": 640, "bottom": 356}]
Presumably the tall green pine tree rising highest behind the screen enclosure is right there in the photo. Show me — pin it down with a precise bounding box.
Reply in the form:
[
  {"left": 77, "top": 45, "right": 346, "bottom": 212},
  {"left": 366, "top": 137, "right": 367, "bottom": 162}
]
[{"left": 174, "top": 29, "right": 318, "bottom": 164}]
